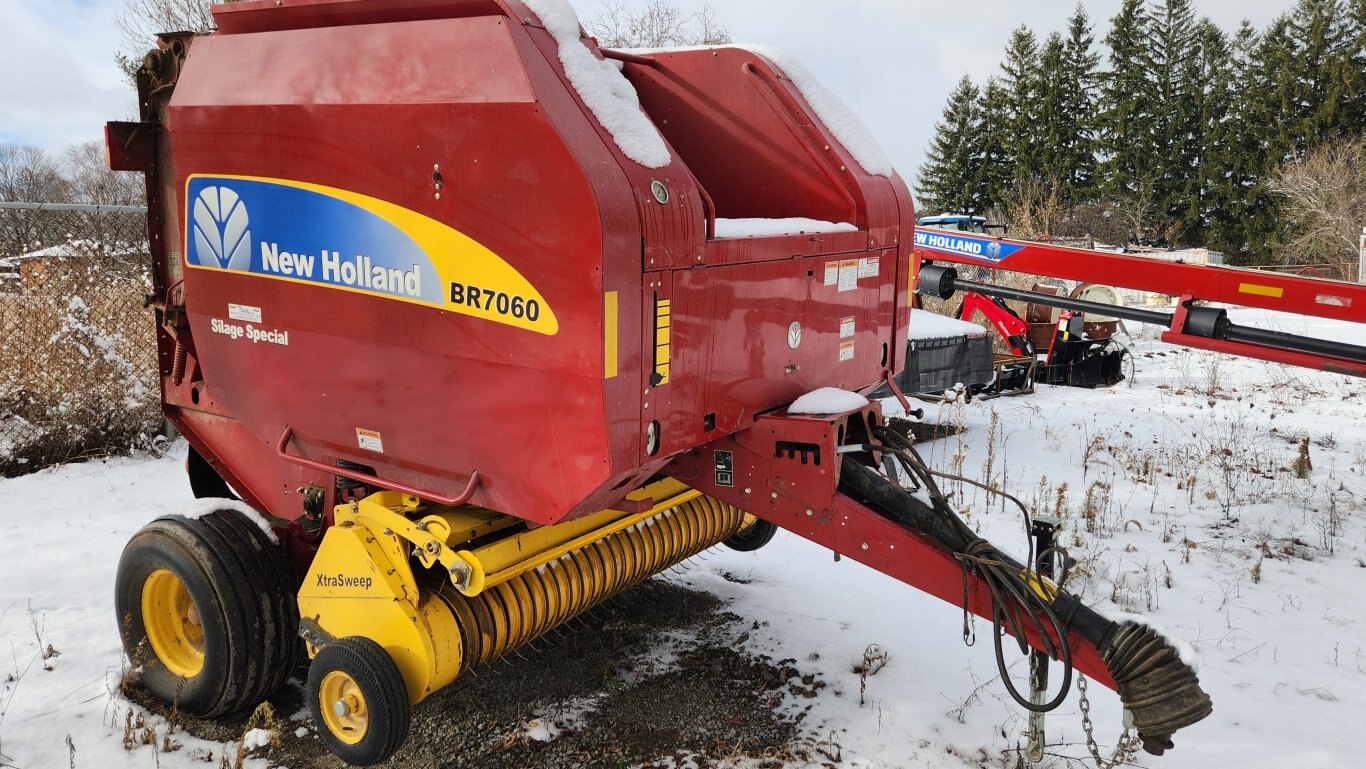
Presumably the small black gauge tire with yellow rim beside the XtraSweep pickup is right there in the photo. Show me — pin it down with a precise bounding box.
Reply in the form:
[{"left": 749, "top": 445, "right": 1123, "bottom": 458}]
[{"left": 307, "top": 635, "right": 410, "bottom": 766}]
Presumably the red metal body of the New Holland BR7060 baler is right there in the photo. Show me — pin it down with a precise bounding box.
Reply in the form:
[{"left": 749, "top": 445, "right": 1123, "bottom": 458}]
[{"left": 144, "top": 0, "right": 914, "bottom": 523}]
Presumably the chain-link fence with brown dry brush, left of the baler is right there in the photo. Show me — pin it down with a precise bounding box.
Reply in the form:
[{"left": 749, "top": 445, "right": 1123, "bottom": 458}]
[{"left": 0, "top": 202, "right": 163, "bottom": 477}]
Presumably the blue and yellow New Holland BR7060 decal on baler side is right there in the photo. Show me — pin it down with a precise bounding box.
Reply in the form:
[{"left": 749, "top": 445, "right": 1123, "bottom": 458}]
[{"left": 184, "top": 175, "right": 559, "bottom": 335}]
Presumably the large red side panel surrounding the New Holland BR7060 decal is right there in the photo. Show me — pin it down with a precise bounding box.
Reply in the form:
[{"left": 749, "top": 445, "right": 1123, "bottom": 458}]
[{"left": 163, "top": 19, "right": 625, "bottom": 520}]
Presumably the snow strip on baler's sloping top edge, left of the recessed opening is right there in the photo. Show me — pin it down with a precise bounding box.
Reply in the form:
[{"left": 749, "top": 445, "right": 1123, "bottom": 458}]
[{"left": 523, "top": 0, "right": 673, "bottom": 168}]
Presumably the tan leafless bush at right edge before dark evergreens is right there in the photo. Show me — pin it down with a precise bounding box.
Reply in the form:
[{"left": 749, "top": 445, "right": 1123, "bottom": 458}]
[{"left": 1272, "top": 137, "right": 1366, "bottom": 280}]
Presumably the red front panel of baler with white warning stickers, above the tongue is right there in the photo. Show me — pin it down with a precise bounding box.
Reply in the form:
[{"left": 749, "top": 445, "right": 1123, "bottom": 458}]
[{"left": 665, "top": 250, "right": 896, "bottom": 451}]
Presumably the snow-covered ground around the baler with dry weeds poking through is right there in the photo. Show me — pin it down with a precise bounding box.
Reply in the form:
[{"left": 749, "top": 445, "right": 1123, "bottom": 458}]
[{"left": 0, "top": 310, "right": 1366, "bottom": 769}]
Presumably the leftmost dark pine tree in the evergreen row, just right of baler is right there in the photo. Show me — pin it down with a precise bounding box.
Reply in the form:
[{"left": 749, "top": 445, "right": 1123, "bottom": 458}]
[{"left": 917, "top": 75, "right": 984, "bottom": 213}]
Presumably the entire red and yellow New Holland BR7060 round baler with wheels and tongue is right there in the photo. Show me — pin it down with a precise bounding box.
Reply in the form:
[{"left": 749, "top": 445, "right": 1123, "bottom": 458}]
[{"left": 108, "top": 0, "right": 1210, "bottom": 765}]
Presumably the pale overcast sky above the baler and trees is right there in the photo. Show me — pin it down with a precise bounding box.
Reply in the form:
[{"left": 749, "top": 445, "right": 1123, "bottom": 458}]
[{"left": 0, "top": 0, "right": 1294, "bottom": 183}]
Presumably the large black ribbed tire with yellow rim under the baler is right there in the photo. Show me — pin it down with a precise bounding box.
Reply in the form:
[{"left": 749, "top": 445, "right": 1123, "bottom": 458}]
[{"left": 115, "top": 509, "right": 302, "bottom": 717}]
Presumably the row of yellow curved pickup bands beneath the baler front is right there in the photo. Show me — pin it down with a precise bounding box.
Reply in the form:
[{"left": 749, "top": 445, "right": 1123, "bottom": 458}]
[{"left": 438, "top": 496, "right": 744, "bottom": 673}]
